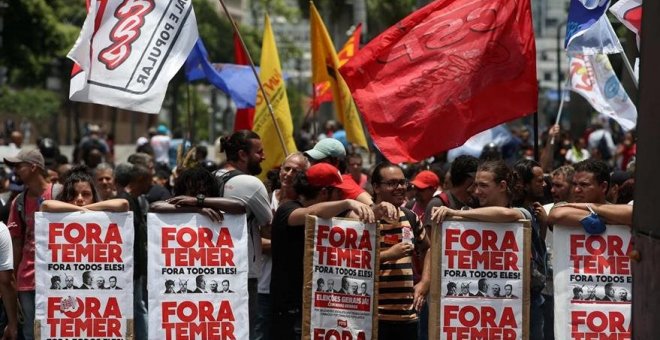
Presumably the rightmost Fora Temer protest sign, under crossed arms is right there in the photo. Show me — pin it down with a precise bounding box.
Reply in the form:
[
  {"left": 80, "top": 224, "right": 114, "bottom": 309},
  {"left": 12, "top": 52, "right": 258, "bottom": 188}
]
[{"left": 552, "top": 225, "right": 632, "bottom": 340}]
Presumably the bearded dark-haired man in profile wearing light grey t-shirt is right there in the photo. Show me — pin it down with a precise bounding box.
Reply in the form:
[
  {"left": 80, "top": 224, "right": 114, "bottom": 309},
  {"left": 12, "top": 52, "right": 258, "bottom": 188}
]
[{"left": 213, "top": 130, "right": 273, "bottom": 334}]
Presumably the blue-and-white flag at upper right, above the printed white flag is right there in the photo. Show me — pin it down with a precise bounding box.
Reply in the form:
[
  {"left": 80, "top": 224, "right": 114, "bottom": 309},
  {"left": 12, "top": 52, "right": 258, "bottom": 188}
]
[{"left": 564, "top": 0, "right": 623, "bottom": 55}]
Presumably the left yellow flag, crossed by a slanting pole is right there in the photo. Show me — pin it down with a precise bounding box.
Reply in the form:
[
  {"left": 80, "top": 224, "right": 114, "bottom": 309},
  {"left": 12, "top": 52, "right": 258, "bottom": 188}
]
[{"left": 252, "top": 15, "right": 297, "bottom": 180}]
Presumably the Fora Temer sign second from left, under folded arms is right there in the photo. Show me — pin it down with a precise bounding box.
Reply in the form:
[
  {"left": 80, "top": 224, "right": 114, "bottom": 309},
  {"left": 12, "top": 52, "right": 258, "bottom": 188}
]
[{"left": 147, "top": 213, "right": 249, "bottom": 340}]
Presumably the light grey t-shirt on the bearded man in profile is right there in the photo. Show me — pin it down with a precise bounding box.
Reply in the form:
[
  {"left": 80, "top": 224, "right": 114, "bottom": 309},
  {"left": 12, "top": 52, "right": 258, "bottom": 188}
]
[{"left": 216, "top": 169, "right": 273, "bottom": 279}]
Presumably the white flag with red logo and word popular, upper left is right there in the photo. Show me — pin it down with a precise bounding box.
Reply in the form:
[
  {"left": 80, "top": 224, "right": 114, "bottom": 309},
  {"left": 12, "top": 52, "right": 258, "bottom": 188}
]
[{"left": 68, "top": 0, "right": 198, "bottom": 113}]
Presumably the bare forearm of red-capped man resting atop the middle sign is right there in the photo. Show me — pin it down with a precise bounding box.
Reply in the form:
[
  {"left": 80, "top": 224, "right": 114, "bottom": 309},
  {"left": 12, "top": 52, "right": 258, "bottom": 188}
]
[{"left": 288, "top": 200, "right": 375, "bottom": 225}]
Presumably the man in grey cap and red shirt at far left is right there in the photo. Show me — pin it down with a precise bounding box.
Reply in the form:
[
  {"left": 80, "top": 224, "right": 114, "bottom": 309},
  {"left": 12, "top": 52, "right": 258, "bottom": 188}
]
[{"left": 4, "top": 149, "right": 61, "bottom": 339}]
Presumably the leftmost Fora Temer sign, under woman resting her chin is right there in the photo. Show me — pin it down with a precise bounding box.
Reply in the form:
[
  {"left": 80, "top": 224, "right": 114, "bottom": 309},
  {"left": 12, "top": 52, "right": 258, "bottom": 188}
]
[{"left": 34, "top": 212, "right": 134, "bottom": 340}]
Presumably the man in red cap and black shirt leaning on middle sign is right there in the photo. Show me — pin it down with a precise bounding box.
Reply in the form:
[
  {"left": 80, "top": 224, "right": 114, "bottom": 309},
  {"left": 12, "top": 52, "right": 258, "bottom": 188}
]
[{"left": 270, "top": 163, "right": 389, "bottom": 339}]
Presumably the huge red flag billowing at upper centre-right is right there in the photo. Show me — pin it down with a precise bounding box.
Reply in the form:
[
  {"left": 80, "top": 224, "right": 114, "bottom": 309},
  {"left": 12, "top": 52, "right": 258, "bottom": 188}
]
[{"left": 341, "top": 0, "right": 538, "bottom": 163}]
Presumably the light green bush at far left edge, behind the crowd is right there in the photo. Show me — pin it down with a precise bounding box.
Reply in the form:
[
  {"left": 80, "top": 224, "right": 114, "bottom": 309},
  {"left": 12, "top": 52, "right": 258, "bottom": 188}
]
[{"left": 0, "top": 87, "right": 62, "bottom": 120}]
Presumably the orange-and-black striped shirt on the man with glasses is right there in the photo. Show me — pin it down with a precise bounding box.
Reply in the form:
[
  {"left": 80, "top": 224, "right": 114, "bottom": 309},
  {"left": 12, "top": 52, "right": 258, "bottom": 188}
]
[{"left": 378, "top": 208, "right": 425, "bottom": 322}]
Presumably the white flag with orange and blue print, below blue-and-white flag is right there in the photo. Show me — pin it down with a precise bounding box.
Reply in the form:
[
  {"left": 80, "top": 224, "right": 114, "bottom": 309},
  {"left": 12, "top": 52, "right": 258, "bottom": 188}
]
[{"left": 570, "top": 54, "right": 637, "bottom": 131}]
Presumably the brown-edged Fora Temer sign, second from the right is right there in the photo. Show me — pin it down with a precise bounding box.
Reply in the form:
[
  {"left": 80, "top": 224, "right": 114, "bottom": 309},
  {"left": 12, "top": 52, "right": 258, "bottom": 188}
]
[{"left": 429, "top": 219, "right": 531, "bottom": 340}]
